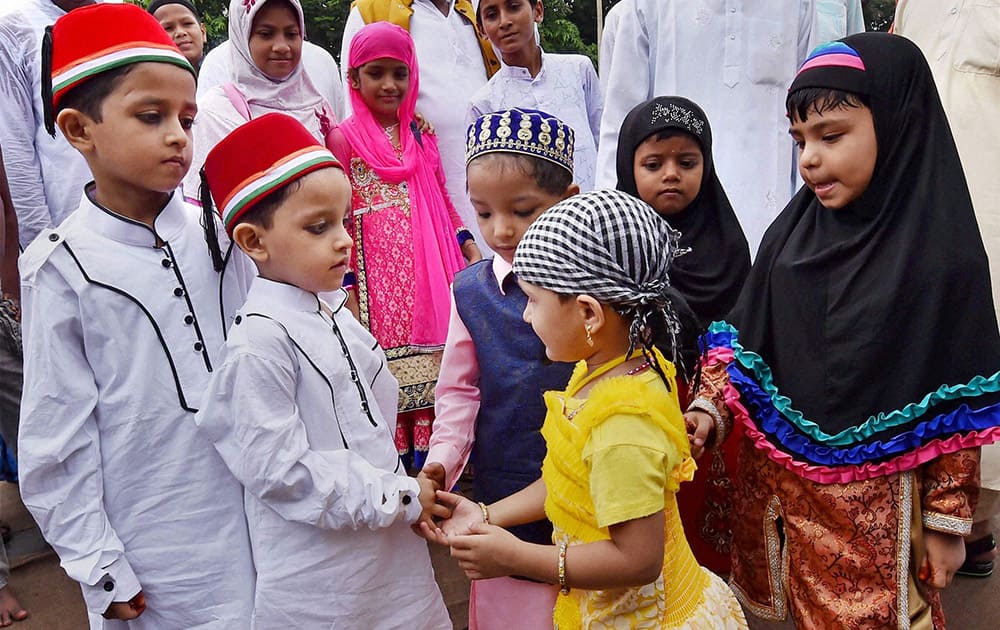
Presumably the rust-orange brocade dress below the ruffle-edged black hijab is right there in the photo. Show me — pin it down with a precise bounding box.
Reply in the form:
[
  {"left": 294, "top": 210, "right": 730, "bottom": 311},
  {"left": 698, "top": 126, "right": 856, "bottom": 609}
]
[{"left": 697, "top": 354, "right": 979, "bottom": 630}]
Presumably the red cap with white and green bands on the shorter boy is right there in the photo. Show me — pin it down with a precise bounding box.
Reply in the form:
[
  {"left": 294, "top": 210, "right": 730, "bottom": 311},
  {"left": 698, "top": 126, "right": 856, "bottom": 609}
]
[{"left": 203, "top": 113, "right": 342, "bottom": 236}]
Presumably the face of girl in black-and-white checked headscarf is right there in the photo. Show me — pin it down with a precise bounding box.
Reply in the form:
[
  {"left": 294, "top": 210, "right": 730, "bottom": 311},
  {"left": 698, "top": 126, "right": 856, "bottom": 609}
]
[{"left": 517, "top": 280, "right": 594, "bottom": 363}]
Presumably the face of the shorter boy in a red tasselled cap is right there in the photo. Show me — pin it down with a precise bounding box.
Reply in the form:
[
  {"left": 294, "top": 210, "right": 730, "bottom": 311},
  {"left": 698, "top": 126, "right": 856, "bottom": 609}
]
[{"left": 247, "top": 168, "right": 352, "bottom": 293}]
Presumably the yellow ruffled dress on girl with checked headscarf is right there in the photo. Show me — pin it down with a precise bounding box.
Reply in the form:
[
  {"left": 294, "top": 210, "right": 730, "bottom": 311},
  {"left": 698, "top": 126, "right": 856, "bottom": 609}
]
[{"left": 542, "top": 353, "right": 747, "bottom": 630}]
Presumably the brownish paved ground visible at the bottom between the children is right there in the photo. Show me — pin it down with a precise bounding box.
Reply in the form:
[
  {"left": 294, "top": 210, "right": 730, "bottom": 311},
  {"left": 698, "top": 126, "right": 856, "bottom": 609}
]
[{"left": 0, "top": 483, "right": 1000, "bottom": 630}]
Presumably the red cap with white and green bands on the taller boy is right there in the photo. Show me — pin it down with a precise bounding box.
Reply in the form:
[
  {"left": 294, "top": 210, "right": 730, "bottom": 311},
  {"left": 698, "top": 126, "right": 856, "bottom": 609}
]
[{"left": 42, "top": 4, "right": 197, "bottom": 134}]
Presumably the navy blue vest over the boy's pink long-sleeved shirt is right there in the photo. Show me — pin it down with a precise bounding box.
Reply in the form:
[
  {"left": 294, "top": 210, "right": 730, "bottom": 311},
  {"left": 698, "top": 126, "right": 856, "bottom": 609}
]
[{"left": 453, "top": 260, "right": 573, "bottom": 544}]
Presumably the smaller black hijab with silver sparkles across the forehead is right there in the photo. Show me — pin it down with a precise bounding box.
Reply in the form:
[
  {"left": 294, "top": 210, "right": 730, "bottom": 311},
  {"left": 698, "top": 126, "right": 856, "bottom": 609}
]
[{"left": 618, "top": 96, "right": 750, "bottom": 326}]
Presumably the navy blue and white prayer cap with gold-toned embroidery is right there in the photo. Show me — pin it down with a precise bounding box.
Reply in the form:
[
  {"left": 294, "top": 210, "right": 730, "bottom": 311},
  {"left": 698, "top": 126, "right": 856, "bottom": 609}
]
[{"left": 465, "top": 108, "right": 574, "bottom": 175}]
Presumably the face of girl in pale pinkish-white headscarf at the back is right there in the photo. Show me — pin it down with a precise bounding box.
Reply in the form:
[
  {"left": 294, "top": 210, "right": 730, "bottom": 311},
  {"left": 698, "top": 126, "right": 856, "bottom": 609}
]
[{"left": 250, "top": 0, "right": 302, "bottom": 81}]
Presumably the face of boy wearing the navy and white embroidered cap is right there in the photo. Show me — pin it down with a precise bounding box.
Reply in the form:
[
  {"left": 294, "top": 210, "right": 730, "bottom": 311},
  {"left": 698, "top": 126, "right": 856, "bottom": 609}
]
[{"left": 466, "top": 160, "right": 578, "bottom": 263}]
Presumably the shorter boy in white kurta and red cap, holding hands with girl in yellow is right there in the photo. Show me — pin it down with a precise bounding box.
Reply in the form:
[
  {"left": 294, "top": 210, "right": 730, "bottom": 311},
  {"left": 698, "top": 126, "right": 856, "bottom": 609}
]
[{"left": 196, "top": 114, "right": 451, "bottom": 630}]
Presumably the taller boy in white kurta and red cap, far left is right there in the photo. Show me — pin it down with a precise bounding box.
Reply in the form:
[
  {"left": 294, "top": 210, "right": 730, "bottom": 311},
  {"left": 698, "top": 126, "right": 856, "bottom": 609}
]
[{"left": 19, "top": 4, "right": 253, "bottom": 630}]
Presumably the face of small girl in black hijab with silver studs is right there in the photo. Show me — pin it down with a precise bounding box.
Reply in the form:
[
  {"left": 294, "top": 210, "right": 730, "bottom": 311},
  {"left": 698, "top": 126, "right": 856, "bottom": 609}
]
[{"left": 632, "top": 133, "right": 705, "bottom": 216}]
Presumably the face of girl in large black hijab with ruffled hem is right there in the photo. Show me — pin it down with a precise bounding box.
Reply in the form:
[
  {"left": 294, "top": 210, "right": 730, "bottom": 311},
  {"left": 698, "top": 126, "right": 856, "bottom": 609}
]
[{"left": 789, "top": 105, "right": 878, "bottom": 210}]
